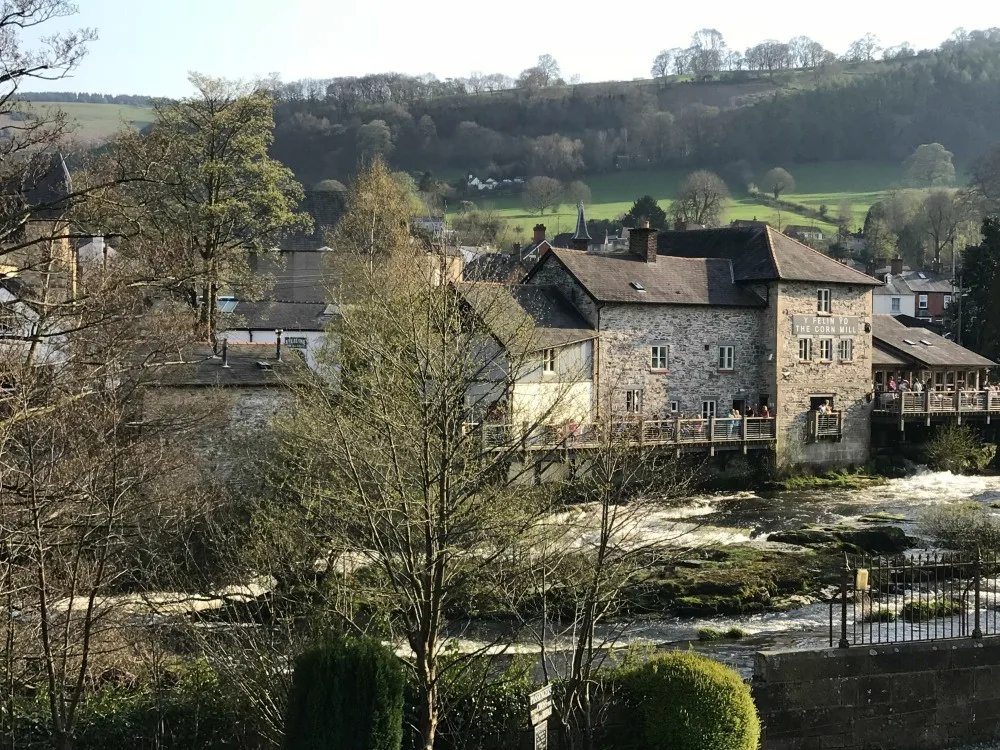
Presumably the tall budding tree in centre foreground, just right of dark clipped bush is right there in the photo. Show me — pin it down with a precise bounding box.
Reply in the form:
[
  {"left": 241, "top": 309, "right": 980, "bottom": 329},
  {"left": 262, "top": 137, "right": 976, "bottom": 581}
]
[{"left": 270, "top": 164, "right": 579, "bottom": 750}]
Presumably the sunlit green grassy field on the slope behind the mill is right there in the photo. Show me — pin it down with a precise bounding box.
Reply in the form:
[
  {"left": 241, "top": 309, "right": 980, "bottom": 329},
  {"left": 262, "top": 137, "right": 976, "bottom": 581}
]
[{"left": 452, "top": 162, "right": 902, "bottom": 236}]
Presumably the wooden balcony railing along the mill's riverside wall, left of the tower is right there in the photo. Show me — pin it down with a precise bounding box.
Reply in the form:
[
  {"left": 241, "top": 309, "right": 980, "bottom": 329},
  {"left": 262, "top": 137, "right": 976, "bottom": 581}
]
[{"left": 465, "top": 417, "right": 776, "bottom": 450}]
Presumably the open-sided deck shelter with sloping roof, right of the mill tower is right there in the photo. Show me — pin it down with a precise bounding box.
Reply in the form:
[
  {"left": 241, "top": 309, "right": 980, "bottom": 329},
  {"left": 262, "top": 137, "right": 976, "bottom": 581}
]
[{"left": 872, "top": 315, "right": 997, "bottom": 391}]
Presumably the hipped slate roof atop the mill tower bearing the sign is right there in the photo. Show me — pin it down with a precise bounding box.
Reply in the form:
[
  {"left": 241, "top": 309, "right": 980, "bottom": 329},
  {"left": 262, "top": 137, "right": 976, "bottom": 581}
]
[{"left": 657, "top": 226, "right": 881, "bottom": 286}]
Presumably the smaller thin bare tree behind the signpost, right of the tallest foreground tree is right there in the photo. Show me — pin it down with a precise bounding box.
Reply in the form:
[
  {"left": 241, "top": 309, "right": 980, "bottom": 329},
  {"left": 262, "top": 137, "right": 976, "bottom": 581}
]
[{"left": 532, "top": 418, "right": 691, "bottom": 750}]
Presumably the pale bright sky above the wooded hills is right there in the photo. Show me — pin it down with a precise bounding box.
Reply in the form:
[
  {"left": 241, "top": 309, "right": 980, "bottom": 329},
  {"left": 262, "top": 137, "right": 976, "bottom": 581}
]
[{"left": 26, "top": 0, "right": 1000, "bottom": 97}]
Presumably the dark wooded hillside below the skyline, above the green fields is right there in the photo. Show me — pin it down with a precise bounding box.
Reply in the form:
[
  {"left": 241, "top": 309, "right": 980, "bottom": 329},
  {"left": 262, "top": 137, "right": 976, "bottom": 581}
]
[{"left": 273, "top": 31, "right": 1000, "bottom": 193}]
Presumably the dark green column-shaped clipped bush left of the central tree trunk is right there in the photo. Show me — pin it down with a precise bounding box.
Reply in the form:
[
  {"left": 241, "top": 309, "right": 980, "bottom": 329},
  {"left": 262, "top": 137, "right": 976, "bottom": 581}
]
[{"left": 285, "top": 638, "right": 403, "bottom": 750}]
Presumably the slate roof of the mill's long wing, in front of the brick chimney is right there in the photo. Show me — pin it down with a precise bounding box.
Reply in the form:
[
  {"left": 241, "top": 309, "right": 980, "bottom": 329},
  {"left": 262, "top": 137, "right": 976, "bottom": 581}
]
[{"left": 529, "top": 249, "right": 766, "bottom": 307}]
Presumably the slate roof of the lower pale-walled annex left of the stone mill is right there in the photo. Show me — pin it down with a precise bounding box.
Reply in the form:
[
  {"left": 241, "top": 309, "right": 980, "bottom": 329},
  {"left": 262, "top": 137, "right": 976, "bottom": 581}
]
[{"left": 458, "top": 283, "right": 597, "bottom": 350}]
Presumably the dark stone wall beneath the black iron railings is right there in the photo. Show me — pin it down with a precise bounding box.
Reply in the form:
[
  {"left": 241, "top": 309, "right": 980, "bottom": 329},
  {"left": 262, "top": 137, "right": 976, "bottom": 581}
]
[{"left": 753, "top": 637, "right": 1000, "bottom": 750}]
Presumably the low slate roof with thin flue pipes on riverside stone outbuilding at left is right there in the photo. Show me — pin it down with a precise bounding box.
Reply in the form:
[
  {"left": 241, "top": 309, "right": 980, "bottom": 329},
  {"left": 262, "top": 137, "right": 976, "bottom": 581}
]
[{"left": 150, "top": 344, "right": 307, "bottom": 388}]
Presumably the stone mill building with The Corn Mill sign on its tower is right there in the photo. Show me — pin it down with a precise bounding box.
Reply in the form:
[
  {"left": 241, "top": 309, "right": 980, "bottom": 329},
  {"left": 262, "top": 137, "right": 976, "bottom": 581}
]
[{"left": 522, "top": 210, "right": 880, "bottom": 466}]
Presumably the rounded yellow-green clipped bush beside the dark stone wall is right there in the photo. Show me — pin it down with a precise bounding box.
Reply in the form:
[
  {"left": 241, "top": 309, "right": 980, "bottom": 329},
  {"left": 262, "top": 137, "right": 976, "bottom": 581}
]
[{"left": 622, "top": 652, "right": 760, "bottom": 750}]
